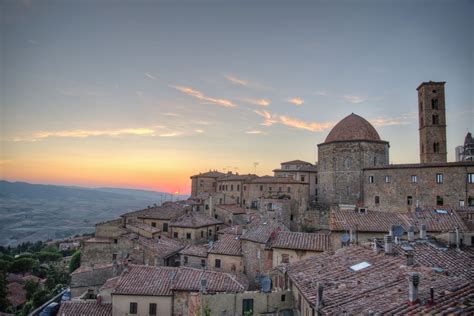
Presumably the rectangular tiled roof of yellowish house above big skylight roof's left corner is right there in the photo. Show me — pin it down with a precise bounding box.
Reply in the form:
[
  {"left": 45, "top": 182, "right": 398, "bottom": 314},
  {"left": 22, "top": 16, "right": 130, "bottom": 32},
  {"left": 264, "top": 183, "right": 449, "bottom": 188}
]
[{"left": 272, "top": 231, "right": 330, "bottom": 251}]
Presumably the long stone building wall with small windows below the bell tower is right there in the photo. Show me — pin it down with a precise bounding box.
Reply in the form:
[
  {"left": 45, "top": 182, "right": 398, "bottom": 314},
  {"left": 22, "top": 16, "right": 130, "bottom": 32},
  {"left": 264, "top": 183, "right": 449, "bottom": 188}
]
[{"left": 363, "top": 162, "right": 474, "bottom": 212}]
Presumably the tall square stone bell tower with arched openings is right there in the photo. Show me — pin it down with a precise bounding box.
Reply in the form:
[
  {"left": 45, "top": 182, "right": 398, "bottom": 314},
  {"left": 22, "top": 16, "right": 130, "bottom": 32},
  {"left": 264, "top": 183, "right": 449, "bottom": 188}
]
[{"left": 416, "top": 81, "right": 447, "bottom": 163}]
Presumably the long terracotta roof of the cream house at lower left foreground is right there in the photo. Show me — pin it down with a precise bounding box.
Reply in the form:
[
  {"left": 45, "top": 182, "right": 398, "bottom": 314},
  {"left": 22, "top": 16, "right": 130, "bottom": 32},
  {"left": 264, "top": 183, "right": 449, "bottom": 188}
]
[{"left": 113, "top": 265, "right": 248, "bottom": 296}]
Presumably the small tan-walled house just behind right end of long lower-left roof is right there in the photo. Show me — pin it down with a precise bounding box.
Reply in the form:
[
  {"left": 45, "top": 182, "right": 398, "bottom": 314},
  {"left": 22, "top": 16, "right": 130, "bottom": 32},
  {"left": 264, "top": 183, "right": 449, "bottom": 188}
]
[{"left": 208, "top": 234, "right": 244, "bottom": 273}]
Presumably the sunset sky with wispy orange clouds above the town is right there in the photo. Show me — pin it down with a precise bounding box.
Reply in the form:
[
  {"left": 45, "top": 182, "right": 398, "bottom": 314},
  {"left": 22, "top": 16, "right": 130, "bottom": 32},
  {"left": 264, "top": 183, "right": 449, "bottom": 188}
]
[{"left": 0, "top": 0, "right": 474, "bottom": 193}]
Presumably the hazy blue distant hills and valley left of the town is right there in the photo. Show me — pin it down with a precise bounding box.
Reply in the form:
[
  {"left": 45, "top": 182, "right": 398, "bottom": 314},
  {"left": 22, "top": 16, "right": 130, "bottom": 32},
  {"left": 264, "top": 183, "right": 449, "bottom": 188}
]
[{"left": 0, "top": 181, "right": 186, "bottom": 246}]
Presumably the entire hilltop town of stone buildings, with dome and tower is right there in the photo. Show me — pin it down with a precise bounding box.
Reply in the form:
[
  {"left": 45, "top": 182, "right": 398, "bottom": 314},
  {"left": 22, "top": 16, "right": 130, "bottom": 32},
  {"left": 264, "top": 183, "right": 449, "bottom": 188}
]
[{"left": 54, "top": 81, "right": 474, "bottom": 316}]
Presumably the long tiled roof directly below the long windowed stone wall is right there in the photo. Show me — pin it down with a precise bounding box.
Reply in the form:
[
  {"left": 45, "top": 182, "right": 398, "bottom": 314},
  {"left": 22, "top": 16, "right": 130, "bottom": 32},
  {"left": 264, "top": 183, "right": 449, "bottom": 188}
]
[{"left": 329, "top": 209, "right": 467, "bottom": 232}]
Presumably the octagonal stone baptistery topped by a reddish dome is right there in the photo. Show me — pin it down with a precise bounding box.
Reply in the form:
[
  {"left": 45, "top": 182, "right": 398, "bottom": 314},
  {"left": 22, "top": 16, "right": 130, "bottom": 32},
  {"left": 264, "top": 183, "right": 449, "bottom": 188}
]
[{"left": 317, "top": 113, "right": 389, "bottom": 207}]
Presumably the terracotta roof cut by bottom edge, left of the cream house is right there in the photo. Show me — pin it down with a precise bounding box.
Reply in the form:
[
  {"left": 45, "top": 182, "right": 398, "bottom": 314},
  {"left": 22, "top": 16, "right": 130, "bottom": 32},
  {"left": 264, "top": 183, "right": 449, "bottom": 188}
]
[{"left": 58, "top": 300, "right": 112, "bottom": 316}]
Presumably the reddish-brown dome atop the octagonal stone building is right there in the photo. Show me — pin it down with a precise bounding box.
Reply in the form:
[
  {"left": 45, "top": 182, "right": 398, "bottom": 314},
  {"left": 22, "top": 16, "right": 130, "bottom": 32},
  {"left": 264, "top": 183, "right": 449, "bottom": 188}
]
[{"left": 325, "top": 113, "right": 380, "bottom": 143}]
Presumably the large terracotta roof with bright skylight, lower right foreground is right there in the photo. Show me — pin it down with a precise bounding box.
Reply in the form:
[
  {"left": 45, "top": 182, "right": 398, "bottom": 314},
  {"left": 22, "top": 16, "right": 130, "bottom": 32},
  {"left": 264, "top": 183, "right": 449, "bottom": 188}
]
[{"left": 279, "top": 242, "right": 474, "bottom": 315}]
